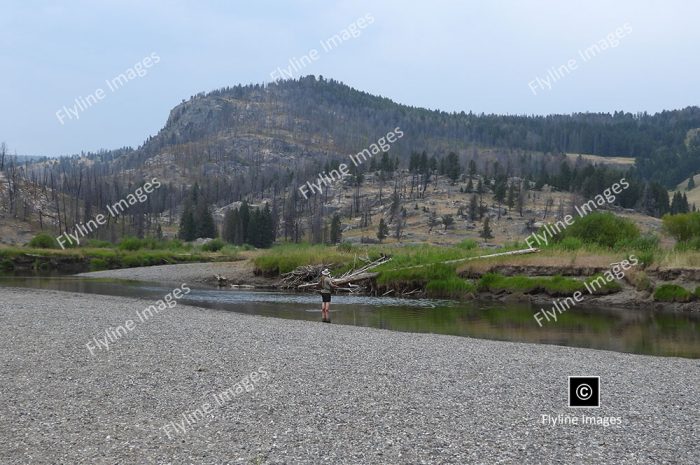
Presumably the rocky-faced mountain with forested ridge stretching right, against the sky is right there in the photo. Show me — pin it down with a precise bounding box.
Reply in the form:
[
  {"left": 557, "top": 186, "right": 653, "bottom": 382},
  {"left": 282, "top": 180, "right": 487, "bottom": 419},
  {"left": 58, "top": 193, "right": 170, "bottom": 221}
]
[{"left": 110, "top": 76, "right": 700, "bottom": 180}]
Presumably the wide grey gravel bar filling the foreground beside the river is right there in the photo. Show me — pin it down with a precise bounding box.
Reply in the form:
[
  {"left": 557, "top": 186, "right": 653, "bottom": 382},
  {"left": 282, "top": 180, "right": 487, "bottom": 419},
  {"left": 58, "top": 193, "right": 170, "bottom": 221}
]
[{"left": 0, "top": 288, "right": 700, "bottom": 464}]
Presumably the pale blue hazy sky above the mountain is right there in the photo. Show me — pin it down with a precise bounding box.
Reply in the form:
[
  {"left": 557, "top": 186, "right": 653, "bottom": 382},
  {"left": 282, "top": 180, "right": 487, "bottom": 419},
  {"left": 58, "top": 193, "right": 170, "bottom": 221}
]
[{"left": 0, "top": 0, "right": 700, "bottom": 156}]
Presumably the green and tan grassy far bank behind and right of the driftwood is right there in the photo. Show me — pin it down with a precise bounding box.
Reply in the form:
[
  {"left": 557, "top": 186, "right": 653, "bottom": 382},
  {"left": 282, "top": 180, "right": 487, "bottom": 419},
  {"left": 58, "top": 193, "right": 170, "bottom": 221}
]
[{"left": 254, "top": 240, "right": 700, "bottom": 302}]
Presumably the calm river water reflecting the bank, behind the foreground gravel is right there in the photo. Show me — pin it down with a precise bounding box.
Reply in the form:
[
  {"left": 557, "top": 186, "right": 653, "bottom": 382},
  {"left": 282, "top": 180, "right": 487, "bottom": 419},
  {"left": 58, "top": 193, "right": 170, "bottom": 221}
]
[{"left": 0, "top": 277, "right": 700, "bottom": 358}]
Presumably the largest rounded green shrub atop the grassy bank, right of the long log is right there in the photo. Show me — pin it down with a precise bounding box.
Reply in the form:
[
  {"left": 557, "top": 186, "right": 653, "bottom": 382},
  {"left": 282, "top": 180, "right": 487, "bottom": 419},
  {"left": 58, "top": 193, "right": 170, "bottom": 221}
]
[{"left": 555, "top": 212, "right": 639, "bottom": 248}]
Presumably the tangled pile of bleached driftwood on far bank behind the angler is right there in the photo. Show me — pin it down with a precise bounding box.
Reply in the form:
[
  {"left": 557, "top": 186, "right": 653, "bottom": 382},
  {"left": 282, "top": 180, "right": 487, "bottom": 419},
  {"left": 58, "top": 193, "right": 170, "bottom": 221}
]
[{"left": 281, "top": 255, "right": 391, "bottom": 292}]
